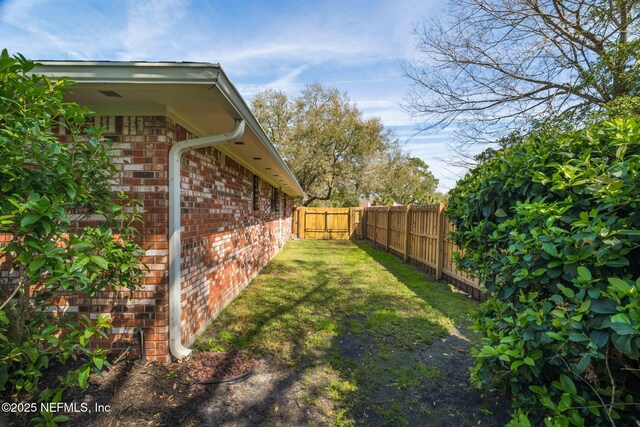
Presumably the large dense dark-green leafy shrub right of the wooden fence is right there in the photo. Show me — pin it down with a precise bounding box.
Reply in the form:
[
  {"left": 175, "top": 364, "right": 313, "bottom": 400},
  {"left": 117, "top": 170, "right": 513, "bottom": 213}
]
[{"left": 447, "top": 119, "right": 640, "bottom": 426}]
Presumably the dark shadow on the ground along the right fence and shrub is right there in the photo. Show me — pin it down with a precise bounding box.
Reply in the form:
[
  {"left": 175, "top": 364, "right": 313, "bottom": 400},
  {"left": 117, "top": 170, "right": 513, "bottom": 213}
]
[{"left": 328, "top": 242, "right": 510, "bottom": 427}]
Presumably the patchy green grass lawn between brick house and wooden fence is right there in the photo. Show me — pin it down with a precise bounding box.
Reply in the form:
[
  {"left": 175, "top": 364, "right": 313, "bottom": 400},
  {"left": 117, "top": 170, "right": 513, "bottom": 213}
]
[{"left": 196, "top": 240, "right": 488, "bottom": 425}]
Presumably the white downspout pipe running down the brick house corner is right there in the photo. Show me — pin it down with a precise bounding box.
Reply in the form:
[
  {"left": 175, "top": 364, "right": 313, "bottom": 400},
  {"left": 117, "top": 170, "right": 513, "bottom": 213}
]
[{"left": 169, "top": 120, "right": 245, "bottom": 359}]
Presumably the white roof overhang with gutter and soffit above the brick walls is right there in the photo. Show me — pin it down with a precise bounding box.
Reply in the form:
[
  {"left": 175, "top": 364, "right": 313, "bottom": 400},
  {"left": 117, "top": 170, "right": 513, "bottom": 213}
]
[{"left": 32, "top": 61, "right": 304, "bottom": 197}]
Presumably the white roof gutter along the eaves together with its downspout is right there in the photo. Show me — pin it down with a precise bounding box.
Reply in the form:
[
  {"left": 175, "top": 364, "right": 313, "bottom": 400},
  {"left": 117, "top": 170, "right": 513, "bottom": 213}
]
[{"left": 32, "top": 58, "right": 304, "bottom": 356}]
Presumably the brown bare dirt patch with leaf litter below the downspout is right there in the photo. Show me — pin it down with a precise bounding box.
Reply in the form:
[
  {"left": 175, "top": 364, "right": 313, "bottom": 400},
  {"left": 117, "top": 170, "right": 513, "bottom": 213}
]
[{"left": 5, "top": 352, "right": 331, "bottom": 427}]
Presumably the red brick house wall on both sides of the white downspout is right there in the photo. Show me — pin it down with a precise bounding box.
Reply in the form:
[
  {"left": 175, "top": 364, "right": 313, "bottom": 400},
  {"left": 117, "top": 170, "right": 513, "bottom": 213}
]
[{"left": 0, "top": 116, "right": 293, "bottom": 362}]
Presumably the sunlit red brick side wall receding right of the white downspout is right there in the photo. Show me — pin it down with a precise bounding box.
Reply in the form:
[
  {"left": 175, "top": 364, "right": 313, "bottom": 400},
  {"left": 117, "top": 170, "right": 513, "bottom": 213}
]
[{"left": 181, "top": 143, "right": 291, "bottom": 342}]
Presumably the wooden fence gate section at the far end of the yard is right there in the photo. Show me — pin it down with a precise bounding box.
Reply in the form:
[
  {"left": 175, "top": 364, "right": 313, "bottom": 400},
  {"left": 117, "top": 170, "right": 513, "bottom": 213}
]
[{"left": 293, "top": 207, "right": 362, "bottom": 239}]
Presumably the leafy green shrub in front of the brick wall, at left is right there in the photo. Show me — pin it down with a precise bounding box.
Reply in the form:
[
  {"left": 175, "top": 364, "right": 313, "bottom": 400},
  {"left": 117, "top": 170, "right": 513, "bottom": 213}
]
[{"left": 0, "top": 50, "right": 143, "bottom": 423}]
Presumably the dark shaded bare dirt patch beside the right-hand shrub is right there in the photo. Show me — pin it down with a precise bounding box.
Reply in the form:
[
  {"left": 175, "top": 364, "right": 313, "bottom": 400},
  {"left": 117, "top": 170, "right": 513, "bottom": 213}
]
[{"left": 337, "top": 327, "right": 511, "bottom": 427}]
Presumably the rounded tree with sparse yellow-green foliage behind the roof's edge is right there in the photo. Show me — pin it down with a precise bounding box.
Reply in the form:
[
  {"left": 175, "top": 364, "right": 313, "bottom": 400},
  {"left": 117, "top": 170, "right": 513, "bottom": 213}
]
[{"left": 252, "top": 83, "right": 395, "bottom": 206}]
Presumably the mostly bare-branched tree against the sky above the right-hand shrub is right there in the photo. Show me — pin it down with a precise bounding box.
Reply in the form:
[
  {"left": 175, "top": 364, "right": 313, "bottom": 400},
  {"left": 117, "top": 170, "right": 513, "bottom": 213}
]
[{"left": 406, "top": 0, "right": 640, "bottom": 142}]
